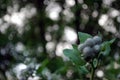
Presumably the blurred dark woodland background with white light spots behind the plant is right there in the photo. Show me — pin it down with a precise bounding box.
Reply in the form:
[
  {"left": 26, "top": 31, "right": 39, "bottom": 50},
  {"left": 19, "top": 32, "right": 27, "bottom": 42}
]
[{"left": 0, "top": 0, "right": 120, "bottom": 80}]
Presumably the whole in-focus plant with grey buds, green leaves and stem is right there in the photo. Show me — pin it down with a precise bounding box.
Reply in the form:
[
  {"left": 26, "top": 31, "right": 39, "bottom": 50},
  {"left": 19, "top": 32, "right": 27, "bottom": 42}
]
[{"left": 63, "top": 32, "right": 115, "bottom": 80}]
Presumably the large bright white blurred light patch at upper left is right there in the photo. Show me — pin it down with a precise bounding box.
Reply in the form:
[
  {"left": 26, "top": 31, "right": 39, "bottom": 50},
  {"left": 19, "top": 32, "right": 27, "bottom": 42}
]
[{"left": 1, "top": 4, "right": 37, "bottom": 34}]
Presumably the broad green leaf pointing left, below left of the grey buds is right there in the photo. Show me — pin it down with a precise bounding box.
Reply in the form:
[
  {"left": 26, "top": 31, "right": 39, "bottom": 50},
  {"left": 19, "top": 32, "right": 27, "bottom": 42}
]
[{"left": 63, "top": 49, "right": 85, "bottom": 66}]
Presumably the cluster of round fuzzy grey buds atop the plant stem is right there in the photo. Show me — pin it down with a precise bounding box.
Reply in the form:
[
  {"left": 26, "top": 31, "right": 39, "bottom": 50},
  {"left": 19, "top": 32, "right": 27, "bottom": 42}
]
[{"left": 78, "top": 36, "right": 102, "bottom": 61}]
